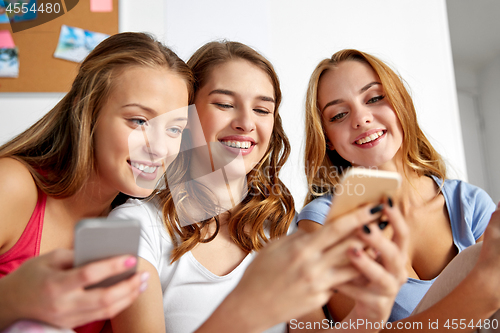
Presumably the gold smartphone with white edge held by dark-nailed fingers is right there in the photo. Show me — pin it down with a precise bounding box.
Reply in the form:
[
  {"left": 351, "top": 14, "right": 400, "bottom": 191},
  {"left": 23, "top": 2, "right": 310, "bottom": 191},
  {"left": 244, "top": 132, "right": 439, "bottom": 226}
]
[{"left": 325, "top": 168, "right": 401, "bottom": 221}]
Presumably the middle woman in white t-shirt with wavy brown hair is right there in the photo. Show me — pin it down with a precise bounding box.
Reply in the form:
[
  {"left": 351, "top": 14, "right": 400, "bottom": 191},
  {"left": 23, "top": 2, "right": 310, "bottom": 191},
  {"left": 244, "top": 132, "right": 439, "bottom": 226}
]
[{"left": 110, "top": 42, "right": 406, "bottom": 333}]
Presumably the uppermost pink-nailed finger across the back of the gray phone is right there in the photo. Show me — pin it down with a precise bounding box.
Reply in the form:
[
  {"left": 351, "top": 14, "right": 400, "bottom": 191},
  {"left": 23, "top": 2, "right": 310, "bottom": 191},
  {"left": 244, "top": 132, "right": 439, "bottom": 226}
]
[{"left": 60, "top": 255, "right": 137, "bottom": 290}]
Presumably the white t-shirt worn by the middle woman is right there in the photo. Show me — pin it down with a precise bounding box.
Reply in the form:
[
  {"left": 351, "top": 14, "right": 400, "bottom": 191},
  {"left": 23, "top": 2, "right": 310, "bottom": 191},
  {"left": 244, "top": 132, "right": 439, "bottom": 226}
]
[{"left": 109, "top": 199, "right": 296, "bottom": 333}]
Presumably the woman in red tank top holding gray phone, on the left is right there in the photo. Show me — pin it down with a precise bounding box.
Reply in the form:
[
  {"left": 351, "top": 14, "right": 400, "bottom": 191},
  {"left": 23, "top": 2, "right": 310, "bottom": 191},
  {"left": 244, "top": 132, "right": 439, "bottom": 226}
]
[{"left": 0, "top": 33, "right": 193, "bottom": 332}]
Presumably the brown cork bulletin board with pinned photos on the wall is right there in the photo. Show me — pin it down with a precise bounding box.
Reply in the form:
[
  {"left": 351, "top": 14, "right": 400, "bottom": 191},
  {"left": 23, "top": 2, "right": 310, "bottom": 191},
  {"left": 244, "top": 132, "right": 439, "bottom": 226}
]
[{"left": 0, "top": 0, "right": 118, "bottom": 92}]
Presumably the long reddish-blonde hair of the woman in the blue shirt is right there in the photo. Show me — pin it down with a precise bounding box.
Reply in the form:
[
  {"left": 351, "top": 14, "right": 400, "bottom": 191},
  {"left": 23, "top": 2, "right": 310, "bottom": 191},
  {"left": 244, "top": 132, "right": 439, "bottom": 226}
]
[{"left": 304, "top": 49, "right": 446, "bottom": 205}]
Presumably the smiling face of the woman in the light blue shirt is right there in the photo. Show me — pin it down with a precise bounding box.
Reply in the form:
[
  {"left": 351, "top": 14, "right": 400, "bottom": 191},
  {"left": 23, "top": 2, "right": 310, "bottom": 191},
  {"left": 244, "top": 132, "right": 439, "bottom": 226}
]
[{"left": 318, "top": 61, "right": 403, "bottom": 170}]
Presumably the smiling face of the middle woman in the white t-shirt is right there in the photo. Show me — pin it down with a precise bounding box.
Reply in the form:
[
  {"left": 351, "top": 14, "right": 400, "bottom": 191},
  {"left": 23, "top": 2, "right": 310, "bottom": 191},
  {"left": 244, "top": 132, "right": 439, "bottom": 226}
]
[{"left": 192, "top": 59, "right": 275, "bottom": 174}]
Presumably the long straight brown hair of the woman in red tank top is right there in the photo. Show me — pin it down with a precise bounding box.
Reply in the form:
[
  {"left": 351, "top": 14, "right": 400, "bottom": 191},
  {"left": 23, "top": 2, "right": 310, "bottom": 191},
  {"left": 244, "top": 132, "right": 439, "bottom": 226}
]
[{"left": 0, "top": 32, "right": 194, "bottom": 198}]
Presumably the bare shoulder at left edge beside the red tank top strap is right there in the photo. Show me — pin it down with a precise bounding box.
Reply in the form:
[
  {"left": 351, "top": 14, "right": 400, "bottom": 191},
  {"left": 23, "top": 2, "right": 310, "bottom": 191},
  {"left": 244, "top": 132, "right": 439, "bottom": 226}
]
[{"left": 0, "top": 158, "right": 38, "bottom": 252}]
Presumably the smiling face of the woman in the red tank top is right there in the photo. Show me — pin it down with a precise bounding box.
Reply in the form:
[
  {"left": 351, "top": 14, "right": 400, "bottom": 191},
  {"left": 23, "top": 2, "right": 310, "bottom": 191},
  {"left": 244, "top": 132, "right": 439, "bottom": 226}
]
[{"left": 94, "top": 67, "right": 188, "bottom": 197}]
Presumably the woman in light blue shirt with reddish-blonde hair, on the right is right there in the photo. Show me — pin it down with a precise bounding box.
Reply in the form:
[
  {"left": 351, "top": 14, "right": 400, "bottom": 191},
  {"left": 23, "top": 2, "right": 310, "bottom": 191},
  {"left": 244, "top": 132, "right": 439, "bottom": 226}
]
[{"left": 298, "top": 50, "right": 500, "bottom": 331}]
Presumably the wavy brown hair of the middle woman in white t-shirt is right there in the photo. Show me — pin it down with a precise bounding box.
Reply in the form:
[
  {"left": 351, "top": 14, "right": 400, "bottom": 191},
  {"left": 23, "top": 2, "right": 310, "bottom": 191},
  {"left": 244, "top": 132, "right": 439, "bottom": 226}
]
[{"left": 158, "top": 41, "right": 295, "bottom": 262}]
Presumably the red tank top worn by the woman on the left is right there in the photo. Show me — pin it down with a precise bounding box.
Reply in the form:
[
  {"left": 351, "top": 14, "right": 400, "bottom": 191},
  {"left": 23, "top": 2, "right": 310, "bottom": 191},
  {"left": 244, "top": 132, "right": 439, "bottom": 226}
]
[{"left": 0, "top": 190, "right": 105, "bottom": 333}]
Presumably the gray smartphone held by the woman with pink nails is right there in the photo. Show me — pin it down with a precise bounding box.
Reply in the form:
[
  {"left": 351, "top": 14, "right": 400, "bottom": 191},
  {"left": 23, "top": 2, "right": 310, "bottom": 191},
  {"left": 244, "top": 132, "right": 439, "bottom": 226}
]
[{"left": 74, "top": 218, "right": 141, "bottom": 289}]
